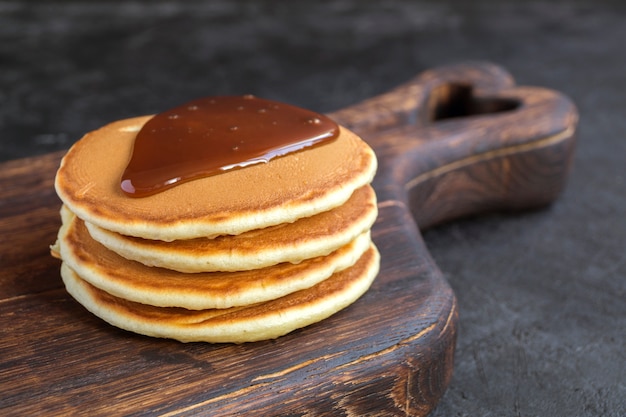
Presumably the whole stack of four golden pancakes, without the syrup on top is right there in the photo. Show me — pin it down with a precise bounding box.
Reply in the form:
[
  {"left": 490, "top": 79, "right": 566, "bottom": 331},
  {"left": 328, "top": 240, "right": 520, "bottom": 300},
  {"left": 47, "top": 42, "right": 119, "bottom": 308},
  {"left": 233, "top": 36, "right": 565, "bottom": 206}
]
[{"left": 52, "top": 111, "right": 379, "bottom": 343}]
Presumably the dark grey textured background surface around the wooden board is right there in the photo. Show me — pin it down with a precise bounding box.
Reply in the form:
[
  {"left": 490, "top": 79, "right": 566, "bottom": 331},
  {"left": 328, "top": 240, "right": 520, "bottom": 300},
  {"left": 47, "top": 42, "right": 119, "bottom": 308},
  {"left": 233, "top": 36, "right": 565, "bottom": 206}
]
[{"left": 0, "top": 0, "right": 626, "bottom": 416}]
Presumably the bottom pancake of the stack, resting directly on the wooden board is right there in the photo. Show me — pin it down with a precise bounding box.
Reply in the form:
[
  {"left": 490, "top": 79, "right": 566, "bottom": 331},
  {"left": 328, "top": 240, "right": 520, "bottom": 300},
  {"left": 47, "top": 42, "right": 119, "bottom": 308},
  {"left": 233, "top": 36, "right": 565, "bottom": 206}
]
[{"left": 61, "top": 245, "right": 379, "bottom": 343}]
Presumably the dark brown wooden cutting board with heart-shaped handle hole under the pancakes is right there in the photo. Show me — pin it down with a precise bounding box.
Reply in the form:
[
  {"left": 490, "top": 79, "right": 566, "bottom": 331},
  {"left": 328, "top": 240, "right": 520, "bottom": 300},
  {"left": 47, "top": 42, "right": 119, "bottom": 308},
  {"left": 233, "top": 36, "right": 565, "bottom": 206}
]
[{"left": 0, "top": 63, "right": 577, "bottom": 416}]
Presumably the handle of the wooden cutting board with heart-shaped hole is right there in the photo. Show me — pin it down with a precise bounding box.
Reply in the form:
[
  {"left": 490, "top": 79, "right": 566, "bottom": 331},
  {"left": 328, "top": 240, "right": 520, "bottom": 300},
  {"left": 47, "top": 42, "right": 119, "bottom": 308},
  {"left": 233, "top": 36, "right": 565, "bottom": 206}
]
[{"left": 331, "top": 62, "right": 578, "bottom": 229}]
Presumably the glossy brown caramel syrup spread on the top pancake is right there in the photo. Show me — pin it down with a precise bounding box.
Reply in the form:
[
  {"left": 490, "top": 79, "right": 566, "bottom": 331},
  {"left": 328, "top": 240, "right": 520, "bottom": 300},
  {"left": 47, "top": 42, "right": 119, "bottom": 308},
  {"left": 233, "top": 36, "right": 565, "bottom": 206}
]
[{"left": 121, "top": 95, "right": 339, "bottom": 197}]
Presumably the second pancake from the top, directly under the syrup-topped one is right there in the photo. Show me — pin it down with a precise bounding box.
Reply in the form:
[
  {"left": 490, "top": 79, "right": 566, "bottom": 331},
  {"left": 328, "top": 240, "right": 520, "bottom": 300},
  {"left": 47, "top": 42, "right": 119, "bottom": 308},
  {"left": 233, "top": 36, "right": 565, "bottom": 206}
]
[{"left": 87, "top": 185, "right": 378, "bottom": 272}]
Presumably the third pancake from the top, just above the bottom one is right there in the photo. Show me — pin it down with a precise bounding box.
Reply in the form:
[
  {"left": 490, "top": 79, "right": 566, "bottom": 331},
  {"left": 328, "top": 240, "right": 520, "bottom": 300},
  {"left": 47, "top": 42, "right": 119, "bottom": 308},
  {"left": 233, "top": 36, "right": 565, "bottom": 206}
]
[{"left": 58, "top": 206, "right": 371, "bottom": 310}]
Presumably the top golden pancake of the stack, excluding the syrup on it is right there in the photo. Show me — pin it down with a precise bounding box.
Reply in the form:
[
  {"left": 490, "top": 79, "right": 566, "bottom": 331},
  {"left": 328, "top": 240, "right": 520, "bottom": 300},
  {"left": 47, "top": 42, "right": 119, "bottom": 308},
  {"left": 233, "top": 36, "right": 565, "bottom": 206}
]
[{"left": 55, "top": 116, "right": 376, "bottom": 241}]
